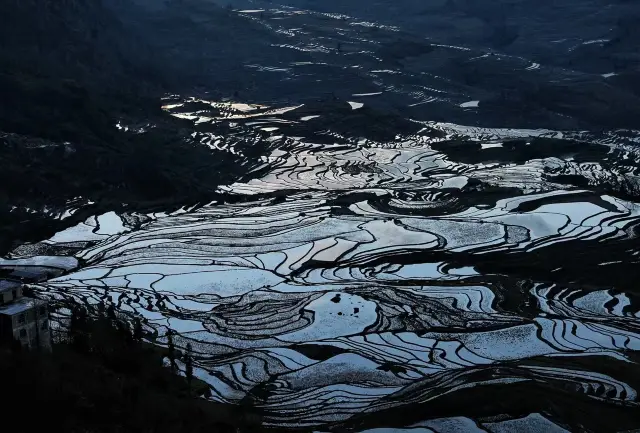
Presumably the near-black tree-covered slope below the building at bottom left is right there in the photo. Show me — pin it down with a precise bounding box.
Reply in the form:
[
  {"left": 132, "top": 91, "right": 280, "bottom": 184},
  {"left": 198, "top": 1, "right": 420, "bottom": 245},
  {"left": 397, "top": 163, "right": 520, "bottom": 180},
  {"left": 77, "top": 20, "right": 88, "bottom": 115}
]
[{"left": 0, "top": 308, "right": 259, "bottom": 433}]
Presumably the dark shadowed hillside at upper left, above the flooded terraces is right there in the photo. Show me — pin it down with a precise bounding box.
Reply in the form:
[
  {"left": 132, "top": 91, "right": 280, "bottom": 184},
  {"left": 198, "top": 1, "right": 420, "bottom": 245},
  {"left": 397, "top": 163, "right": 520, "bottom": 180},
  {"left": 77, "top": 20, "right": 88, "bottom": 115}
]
[{"left": 0, "top": 0, "right": 272, "bottom": 253}]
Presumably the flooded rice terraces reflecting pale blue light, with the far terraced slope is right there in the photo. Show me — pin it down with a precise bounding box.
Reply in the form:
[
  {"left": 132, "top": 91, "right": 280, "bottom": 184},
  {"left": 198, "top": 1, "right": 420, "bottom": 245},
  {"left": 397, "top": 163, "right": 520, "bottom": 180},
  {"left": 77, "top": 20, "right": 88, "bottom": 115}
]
[{"left": 13, "top": 0, "right": 640, "bottom": 433}]
